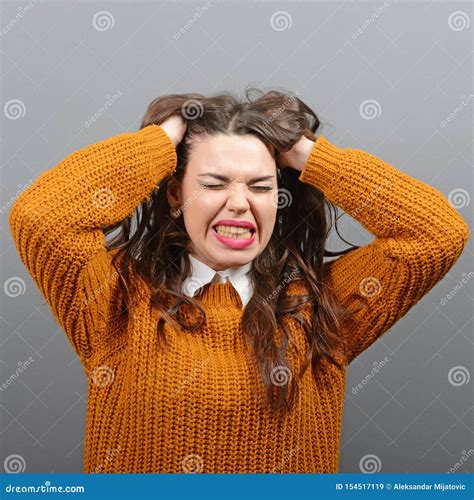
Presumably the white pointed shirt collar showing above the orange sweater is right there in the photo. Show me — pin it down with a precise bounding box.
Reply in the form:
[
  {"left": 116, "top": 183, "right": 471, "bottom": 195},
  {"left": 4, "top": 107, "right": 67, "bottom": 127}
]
[{"left": 182, "top": 254, "right": 253, "bottom": 307}]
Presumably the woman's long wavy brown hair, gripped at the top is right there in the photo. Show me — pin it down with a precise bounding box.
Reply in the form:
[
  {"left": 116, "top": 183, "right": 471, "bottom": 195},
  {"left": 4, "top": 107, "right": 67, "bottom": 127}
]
[{"left": 104, "top": 87, "right": 359, "bottom": 413}]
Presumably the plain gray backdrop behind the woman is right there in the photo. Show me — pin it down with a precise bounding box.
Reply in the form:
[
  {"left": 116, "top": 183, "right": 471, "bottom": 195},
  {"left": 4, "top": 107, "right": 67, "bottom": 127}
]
[{"left": 0, "top": 1, "right": 474, "bottom": 473}]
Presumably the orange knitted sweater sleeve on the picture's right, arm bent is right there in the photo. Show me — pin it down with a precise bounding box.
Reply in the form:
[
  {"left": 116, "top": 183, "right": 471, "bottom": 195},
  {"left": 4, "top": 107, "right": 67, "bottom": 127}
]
[{"left": 299, "top": 136, "right": 469, "bottom": 364}]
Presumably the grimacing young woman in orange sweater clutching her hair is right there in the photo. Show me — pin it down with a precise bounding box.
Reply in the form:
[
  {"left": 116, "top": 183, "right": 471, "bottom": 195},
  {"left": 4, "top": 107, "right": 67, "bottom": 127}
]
[{"left": 10, "top": 91, "right": 469, "bottom": 473}]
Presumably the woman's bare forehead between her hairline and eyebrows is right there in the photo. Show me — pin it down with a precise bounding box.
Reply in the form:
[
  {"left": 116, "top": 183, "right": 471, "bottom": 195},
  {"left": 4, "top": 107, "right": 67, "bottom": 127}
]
[{"left": 188, "top": 134, "right": 276, "bottom": 178}]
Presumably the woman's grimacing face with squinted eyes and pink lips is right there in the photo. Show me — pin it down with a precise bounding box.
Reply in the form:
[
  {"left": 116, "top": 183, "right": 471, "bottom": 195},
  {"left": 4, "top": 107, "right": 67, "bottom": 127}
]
[{"left": 168, "top": 134, "right": 278, "bottom": 271}]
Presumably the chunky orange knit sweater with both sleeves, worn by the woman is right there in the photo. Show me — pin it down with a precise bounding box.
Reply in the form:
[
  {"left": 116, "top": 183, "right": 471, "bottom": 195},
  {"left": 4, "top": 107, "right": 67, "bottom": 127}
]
[{"left": 9, "top": 125, "right": 469, "bottom": 473}]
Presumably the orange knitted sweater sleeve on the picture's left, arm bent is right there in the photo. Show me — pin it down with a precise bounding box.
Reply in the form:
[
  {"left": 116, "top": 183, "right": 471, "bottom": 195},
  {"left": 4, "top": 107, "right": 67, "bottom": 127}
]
[{"left": 9, "top": 124, "right": 177, "bottom": 364}]
